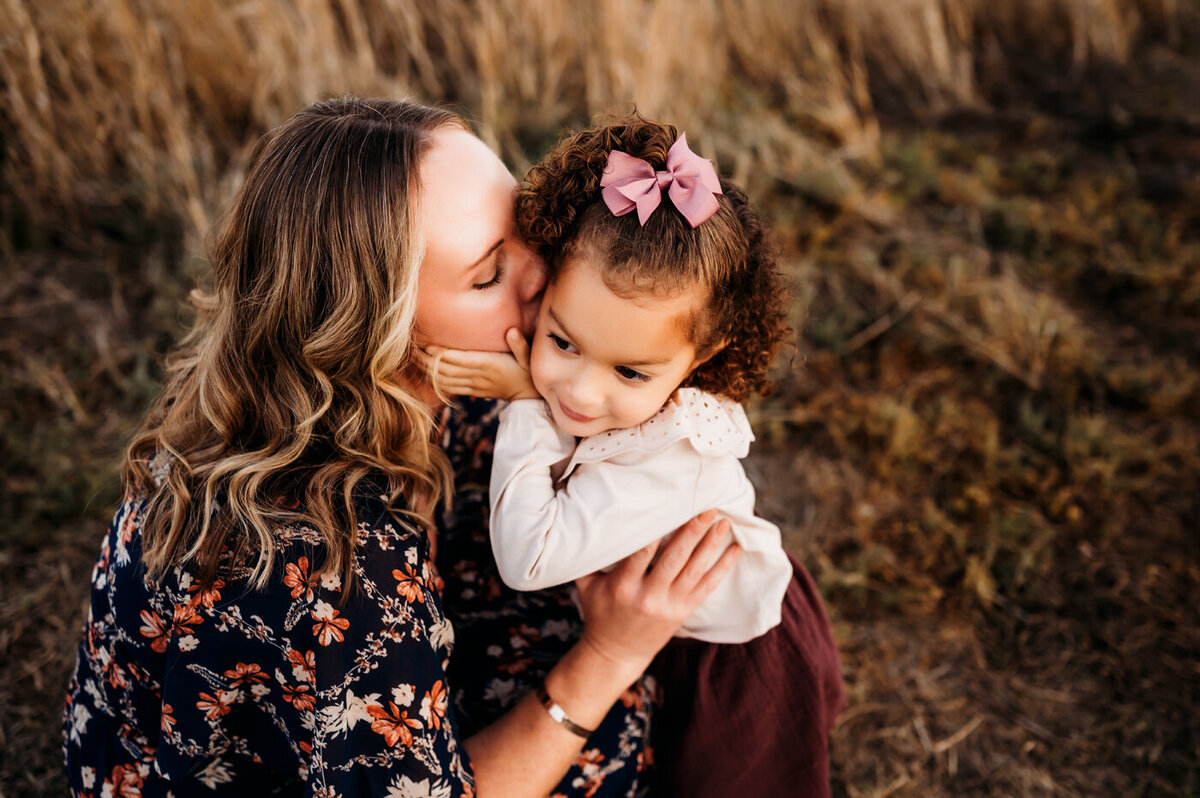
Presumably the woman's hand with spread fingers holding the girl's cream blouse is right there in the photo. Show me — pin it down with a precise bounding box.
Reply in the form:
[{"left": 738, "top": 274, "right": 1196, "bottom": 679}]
[{"left": 575, "top": 510, "right": 742, "bottom": 680}]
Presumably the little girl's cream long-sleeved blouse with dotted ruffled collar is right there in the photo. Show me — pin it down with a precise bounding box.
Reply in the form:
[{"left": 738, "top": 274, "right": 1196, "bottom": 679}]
[{"left": 491, "top": 388, "right": 792, "bottom": 643}]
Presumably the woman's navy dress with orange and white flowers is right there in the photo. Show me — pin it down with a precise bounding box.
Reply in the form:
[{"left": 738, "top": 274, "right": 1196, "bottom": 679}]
[{"left": 64, "top": 403, "right": 654, "bottom": 798}]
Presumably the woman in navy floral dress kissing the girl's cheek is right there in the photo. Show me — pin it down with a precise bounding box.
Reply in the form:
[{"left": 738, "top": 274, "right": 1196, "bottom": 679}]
[{"left": 65, "top": 100, "right": 738, "bottom": 797}]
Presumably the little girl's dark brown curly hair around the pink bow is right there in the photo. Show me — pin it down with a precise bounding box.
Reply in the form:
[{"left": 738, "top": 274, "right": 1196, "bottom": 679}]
[{"left": 517, "top": 114, "right": 788, "bottom": 402}]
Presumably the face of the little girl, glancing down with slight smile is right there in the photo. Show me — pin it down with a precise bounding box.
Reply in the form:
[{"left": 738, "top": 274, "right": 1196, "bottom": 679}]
[{"left": 529, "top": 258, "right": 703, "bottom": 437}]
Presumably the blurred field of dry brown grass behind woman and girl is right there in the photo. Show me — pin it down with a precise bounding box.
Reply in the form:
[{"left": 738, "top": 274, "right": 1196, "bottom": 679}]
[{"left": 0, "top": 0, "right": 1200, "bottom": 798}]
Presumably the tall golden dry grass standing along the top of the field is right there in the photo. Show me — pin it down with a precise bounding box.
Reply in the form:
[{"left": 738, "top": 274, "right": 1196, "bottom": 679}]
[{"left": 0, "top": 0, "right": 1177, "bottom": 245}]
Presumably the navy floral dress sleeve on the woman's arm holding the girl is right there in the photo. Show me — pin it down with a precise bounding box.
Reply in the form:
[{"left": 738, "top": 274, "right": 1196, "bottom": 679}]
[{"left": 297, "top": 501, "right": 474, "bottom": 797}]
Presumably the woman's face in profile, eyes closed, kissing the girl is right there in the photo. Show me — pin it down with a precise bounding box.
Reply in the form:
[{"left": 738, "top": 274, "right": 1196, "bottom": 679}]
[{"left": 414, "top": 128, "right": 546, "bottom": 352}]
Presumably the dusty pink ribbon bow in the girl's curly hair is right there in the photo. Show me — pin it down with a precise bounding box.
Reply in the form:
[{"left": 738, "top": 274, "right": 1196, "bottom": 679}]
[{"left": 600, "top": 133, "right": 721, "bottom": 227}]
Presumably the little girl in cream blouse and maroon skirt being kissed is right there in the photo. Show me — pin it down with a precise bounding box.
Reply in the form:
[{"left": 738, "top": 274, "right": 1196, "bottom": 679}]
[{"left": 436, "top": 118, "right": 845, "bottom": 797}]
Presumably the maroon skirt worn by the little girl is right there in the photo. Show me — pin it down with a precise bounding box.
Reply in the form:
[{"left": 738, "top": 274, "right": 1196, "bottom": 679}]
[{"left": 652, "top": 556, "right": 846, "bottom": 798}]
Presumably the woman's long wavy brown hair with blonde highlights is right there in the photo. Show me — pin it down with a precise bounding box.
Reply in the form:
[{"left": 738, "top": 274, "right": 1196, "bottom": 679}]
[{"left": 122, "top": 98, "right": 467, "bottom": 587}]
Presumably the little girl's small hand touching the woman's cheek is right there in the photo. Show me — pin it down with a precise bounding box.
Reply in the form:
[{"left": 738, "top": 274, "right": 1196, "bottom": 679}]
[{"left": 427, "top": 328, "right": 540, "bottom": 401}]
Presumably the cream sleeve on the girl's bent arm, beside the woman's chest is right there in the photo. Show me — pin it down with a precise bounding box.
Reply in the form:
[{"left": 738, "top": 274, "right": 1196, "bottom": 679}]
[{"left": 491, "top": 400, "right": 702, "bottom": 590}]
